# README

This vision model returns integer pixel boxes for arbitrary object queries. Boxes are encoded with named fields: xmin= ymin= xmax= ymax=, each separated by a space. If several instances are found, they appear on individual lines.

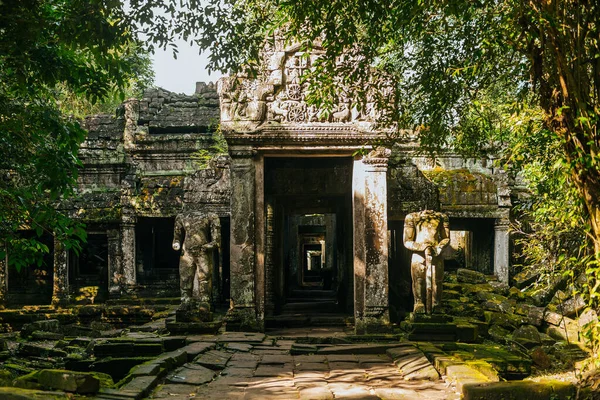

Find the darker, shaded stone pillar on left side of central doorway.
xmin=227 ymin=148 xmax=260 ymax=330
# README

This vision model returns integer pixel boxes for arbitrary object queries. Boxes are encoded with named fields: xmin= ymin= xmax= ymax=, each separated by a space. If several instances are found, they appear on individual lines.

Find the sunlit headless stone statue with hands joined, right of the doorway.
xmin=404 ymin=210 xmax=450 ymax=314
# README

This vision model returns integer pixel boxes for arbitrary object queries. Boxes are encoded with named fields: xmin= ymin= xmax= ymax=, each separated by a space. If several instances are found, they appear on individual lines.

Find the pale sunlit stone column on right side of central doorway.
xmin=357 ymin=149 xmax=389 ymax=331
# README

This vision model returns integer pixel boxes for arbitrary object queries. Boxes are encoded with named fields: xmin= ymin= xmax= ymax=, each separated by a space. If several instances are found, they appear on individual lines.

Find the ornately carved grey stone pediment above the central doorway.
xmin=218 ymin=38 xmax=391 ymax=128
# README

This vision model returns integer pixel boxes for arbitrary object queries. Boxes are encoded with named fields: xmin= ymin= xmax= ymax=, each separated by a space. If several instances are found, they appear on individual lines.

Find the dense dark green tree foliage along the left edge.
xmin=0 ymin=0 xmax=149 ymax=269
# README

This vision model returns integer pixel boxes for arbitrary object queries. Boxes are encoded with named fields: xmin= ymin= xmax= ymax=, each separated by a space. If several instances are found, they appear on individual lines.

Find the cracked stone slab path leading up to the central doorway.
xmin=149 ymin=333 xmax=460 ymax=400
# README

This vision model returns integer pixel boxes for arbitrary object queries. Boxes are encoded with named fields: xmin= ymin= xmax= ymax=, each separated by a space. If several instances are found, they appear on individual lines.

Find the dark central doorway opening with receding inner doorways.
xmin=265 ymin=157 xmax=354 ymax=324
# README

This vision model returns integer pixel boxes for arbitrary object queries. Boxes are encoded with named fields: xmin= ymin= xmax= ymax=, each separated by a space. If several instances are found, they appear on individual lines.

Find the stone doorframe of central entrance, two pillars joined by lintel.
xmin=227 ymin=141 xmax=390 ymax=333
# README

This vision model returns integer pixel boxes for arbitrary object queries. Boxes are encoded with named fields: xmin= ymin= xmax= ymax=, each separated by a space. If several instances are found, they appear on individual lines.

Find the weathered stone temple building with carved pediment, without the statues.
xmin=0 ymin=44 xmax=511 ymax=332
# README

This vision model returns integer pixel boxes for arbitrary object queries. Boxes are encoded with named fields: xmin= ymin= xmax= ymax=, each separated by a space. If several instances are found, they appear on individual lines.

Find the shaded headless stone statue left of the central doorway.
xmin=173 ymin=212 xmax=221 ymax=320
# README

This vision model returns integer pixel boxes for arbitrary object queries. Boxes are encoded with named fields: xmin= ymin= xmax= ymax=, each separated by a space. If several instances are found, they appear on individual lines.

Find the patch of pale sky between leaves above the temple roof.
xmin=152 ymin=40 xmax=222 ymax=94
